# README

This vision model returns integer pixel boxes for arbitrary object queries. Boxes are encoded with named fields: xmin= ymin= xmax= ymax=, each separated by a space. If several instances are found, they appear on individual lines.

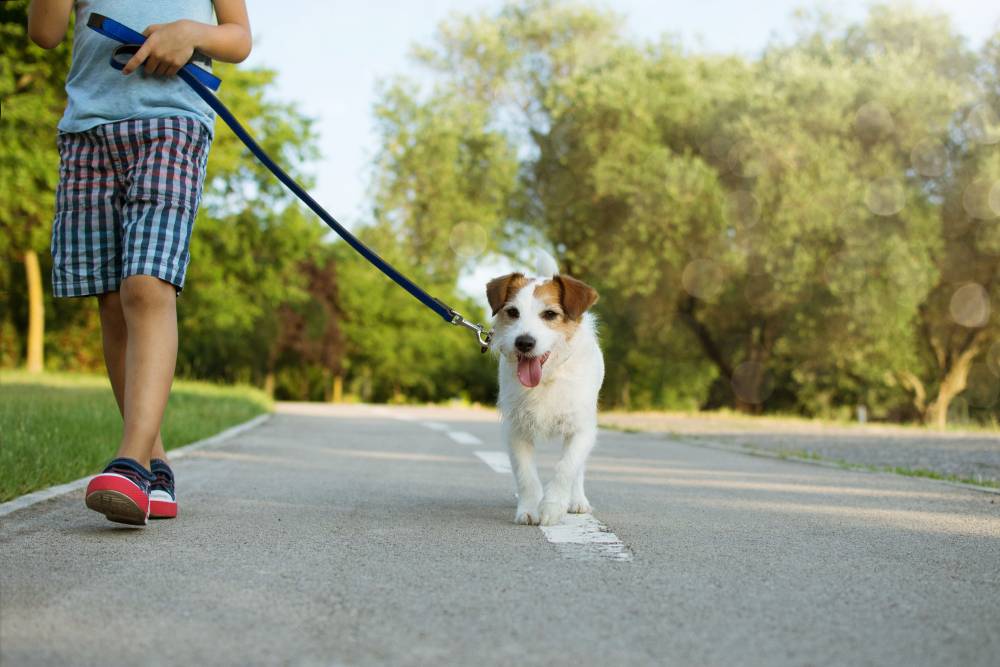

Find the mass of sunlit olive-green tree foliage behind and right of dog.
xmin=372 ymin=0 xmax=1000 ymax=420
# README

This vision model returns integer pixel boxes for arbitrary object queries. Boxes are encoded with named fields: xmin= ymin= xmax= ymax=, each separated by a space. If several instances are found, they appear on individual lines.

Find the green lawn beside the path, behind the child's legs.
xmin=0 ymin=370 xmax=271 ymax=502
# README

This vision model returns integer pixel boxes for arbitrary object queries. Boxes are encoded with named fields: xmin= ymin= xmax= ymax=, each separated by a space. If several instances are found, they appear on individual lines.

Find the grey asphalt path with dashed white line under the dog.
xmin=0 ymin=404 xmax=1000 ymax=667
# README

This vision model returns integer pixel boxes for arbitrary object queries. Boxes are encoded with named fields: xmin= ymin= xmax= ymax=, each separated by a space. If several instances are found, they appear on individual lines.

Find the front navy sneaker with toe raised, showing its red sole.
xmin=86 ymin=459 xmax=156 ymax=526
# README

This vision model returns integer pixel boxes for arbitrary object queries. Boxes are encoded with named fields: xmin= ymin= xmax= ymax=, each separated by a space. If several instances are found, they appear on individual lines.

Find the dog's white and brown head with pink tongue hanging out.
xmin=486 ymin=273 xmax=597 ymax=387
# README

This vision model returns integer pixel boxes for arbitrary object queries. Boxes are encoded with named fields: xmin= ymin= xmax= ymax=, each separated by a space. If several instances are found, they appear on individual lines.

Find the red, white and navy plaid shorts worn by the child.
xmin=52 ymin=116 xmax=212 ymax=297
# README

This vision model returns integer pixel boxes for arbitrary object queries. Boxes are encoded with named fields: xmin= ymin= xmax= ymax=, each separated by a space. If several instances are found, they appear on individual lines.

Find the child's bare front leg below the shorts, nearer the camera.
xmin=109 ymin=275 xmax=177 ymax=469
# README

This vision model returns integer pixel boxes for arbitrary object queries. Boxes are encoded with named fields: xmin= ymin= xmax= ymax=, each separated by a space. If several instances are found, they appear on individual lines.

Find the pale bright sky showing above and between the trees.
xmin=242 ymin=0 xmax=1000 ymax=296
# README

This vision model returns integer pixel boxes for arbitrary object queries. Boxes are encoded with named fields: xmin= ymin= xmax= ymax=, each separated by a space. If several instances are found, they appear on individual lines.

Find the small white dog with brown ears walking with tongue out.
xmin=486 ymin=255 xmax=604 ymax=526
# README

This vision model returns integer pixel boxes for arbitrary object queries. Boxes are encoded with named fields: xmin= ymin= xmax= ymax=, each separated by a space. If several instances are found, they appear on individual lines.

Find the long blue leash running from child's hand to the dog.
xmin=87 ymin=13 xmax=492 ymax=352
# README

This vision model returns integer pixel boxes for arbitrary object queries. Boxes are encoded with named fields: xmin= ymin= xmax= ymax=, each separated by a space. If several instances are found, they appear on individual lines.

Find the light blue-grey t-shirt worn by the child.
xmin=59 ymin=0 xmax=216 ymax=133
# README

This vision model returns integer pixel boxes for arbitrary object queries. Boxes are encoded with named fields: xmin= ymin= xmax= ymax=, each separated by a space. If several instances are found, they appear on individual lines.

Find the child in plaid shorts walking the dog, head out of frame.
xmin=28 ymin=0 xmax=251 ymax=525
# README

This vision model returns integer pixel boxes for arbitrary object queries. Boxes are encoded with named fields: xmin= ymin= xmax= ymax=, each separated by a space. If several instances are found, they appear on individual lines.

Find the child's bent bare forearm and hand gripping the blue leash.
xmin=122 ymin=0 xmax=253 ymax=75
